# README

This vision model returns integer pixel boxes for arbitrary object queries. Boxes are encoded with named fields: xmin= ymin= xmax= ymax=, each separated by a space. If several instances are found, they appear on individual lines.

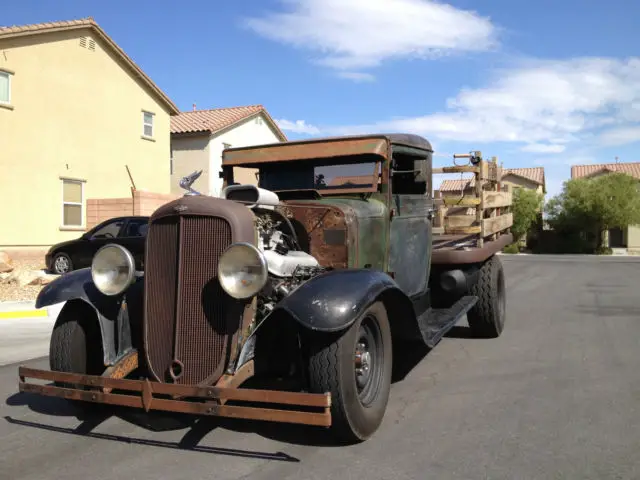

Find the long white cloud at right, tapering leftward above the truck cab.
xmin=308 ymin=58 xmax=640 ymax=153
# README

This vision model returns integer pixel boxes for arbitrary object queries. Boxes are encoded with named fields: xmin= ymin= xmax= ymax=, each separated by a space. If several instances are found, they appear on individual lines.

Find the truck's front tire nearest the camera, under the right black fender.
xmin=309 ymin=302 xmax=392 ymax=443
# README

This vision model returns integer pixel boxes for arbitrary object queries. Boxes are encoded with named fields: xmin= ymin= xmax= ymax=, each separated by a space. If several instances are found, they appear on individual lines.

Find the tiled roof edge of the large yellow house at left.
xmin=0 ymin=17 xmax=180 ymax=115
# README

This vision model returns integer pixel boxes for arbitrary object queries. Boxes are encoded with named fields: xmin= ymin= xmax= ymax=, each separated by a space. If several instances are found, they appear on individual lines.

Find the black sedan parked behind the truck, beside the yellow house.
xmin=45 ymin=216 xmax=149 ymax=275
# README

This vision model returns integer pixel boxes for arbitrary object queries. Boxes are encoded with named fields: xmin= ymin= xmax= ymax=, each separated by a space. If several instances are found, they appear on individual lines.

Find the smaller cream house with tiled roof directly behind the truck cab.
xmin=171 ymin=105 xmax=287 ymax=196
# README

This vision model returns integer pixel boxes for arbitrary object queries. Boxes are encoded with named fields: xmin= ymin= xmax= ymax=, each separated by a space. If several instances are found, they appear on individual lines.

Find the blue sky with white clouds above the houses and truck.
xmin=5 ymin=0 xmax=640 ymax=194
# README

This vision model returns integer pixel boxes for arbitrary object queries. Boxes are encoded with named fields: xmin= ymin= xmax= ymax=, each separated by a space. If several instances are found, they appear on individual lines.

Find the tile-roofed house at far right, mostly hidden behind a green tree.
xmin=571 ymin=162 xmax=640 ymax=254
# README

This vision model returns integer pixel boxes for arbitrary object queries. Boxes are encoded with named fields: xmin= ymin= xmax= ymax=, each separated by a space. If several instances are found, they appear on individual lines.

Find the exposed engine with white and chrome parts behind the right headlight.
xmin=254 ymin=208 xmax=325 ymax=318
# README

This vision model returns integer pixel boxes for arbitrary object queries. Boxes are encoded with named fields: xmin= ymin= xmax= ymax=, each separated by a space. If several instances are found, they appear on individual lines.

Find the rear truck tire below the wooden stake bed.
xmin=467 ymin=255 xmax=506 ymax=338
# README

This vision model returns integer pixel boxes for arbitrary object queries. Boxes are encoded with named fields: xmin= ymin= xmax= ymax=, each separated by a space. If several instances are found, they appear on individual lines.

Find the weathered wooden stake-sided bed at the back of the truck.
xmin=432 ymin=152 xmax=513 ymax=264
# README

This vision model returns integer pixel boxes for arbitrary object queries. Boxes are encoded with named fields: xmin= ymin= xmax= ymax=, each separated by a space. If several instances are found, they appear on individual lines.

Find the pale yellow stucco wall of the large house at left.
xmin=0 ymin=30 xmax=170 ymax=247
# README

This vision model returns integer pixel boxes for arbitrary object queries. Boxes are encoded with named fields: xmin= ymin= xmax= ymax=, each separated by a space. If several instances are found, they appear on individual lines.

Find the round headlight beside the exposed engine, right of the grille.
xmin=218 ymin=243 xmax=268 ymax=298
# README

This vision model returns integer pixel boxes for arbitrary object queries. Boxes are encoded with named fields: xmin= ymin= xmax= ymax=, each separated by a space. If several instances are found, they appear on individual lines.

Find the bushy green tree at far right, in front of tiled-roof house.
xmin=547 ymin=173 xmax=640 ymax=250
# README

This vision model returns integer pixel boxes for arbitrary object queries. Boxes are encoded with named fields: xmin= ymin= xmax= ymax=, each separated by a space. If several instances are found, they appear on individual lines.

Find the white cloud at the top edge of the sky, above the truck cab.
xmin=246 ymin=0 xmax=497 ymax=80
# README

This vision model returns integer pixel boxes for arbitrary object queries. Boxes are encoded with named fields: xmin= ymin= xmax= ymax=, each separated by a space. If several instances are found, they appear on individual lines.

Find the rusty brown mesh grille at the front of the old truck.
xmin=145 ymin=215 xmax=234 ymax=384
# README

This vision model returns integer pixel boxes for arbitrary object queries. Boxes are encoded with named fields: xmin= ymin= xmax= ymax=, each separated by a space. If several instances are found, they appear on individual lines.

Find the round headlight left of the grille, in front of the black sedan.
xmin=91 ymin=243 xmax=136 ymax=295
